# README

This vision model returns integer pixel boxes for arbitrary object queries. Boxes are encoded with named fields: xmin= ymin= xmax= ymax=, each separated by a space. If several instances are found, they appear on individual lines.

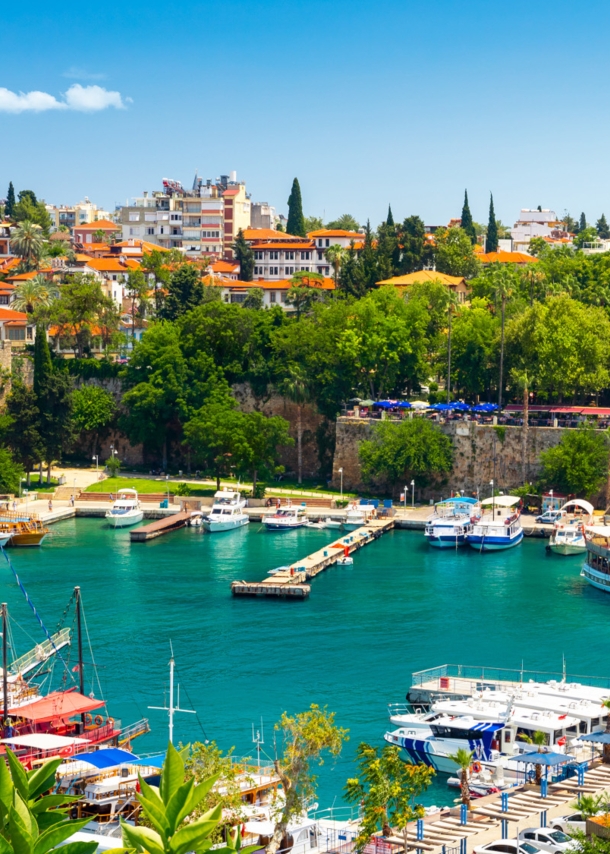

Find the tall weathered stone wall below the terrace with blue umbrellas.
xmin=333 ymin=417 xmax=605 ymax=506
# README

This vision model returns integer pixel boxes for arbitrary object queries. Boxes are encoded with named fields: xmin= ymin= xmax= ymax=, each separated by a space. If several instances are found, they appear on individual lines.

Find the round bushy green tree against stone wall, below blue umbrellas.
xmin=358 ymin=418 xmax=453 ymax=492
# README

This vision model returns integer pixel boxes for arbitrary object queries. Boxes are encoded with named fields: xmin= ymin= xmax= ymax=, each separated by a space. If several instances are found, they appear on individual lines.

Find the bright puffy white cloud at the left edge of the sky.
xmin=0 ymin=83 xmax=131 ymax=113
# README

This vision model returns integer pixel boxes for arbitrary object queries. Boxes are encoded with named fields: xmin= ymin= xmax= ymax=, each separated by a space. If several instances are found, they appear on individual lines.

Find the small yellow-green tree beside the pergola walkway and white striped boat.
xmin=345 ymin=743 xmax=435 ymax=852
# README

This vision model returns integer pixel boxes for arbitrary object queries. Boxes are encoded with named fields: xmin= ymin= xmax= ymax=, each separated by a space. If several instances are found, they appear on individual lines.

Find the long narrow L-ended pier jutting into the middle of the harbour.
xmin=231 ymin=519 xmax=394 ymax=599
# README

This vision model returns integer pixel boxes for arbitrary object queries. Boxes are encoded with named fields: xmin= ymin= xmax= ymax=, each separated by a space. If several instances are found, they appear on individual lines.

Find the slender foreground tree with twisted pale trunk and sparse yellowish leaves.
xmin=266 ymin=704 xmax=347 ymax=854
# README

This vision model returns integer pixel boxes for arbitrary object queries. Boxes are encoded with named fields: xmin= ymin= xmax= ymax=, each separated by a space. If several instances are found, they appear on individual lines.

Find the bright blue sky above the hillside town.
xmin=0 ymin=0 xmax=610 ymax=225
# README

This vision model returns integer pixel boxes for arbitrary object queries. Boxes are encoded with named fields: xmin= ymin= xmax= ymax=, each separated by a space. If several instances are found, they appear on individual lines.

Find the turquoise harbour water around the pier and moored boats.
xmin=2 ymin=519 xmax=610 ymax=806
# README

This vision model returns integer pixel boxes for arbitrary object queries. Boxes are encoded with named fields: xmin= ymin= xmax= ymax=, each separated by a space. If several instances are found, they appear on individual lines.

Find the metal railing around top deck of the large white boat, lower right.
xmin=411 ymin=664 xmax=610 ymax=691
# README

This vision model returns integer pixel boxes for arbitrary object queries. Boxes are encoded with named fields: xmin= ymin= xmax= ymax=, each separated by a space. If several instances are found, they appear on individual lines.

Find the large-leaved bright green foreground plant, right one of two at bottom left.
xmin=122 ymin=743 xmax=256 ymax=854
